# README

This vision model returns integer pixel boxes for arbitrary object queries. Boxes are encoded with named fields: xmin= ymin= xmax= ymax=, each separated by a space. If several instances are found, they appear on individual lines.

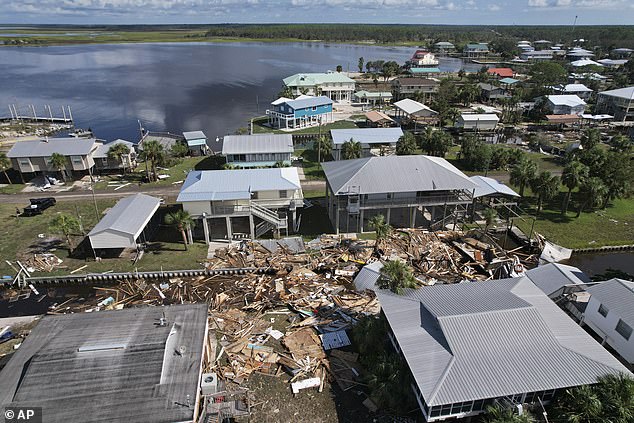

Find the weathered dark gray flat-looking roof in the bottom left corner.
xmin=0 ymin=304 xmax=207 ymax=423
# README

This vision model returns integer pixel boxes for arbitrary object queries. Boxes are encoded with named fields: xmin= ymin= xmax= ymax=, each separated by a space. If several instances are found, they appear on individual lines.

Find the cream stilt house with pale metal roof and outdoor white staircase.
xmin=176 ymin=167 xmax=304 ymax=243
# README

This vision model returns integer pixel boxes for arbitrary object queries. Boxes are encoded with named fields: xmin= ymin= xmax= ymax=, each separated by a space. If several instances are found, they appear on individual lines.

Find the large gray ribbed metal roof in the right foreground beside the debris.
xmin=376 ymin=278 xmax=629 ymax=405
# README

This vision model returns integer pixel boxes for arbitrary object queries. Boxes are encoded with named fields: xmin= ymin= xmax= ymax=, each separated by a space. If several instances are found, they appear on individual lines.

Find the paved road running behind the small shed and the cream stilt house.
xmin=0 ymin=181 xmax=326 ymax=204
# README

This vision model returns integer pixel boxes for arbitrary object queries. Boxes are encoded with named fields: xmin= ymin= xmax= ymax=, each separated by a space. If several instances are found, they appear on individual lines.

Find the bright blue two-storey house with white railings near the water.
xmin=266 ymin=95 xmax=334 ymax=129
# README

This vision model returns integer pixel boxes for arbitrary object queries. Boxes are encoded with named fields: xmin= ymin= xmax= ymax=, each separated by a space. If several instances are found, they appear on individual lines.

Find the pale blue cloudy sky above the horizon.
xmin=0 ymin=0 xmax=634 ymax=25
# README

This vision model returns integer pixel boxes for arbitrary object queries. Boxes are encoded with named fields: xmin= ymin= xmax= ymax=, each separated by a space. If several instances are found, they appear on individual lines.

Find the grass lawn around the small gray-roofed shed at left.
xmin=0 ymin=200 xmax=207 ymax=275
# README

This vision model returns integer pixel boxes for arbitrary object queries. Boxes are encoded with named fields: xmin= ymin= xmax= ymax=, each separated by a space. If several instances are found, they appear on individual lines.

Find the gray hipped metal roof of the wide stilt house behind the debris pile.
xmin=321 ymin=155 xmax=477 ymax=195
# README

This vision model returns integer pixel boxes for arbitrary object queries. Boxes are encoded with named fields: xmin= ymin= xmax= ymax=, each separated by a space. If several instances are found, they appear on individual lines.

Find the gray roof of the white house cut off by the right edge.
xmin=586 ymin=278 xmax=634 ymax=327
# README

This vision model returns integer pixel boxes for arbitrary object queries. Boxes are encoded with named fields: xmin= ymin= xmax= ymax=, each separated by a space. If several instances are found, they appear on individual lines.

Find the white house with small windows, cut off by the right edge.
xmin=581 ymin=279 xmax=634 ymax=364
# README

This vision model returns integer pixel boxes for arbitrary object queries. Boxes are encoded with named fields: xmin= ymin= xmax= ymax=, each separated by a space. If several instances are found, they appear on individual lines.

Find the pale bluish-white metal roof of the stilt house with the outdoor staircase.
xmin=176 ymin=167 xmax=301 ymax=203
